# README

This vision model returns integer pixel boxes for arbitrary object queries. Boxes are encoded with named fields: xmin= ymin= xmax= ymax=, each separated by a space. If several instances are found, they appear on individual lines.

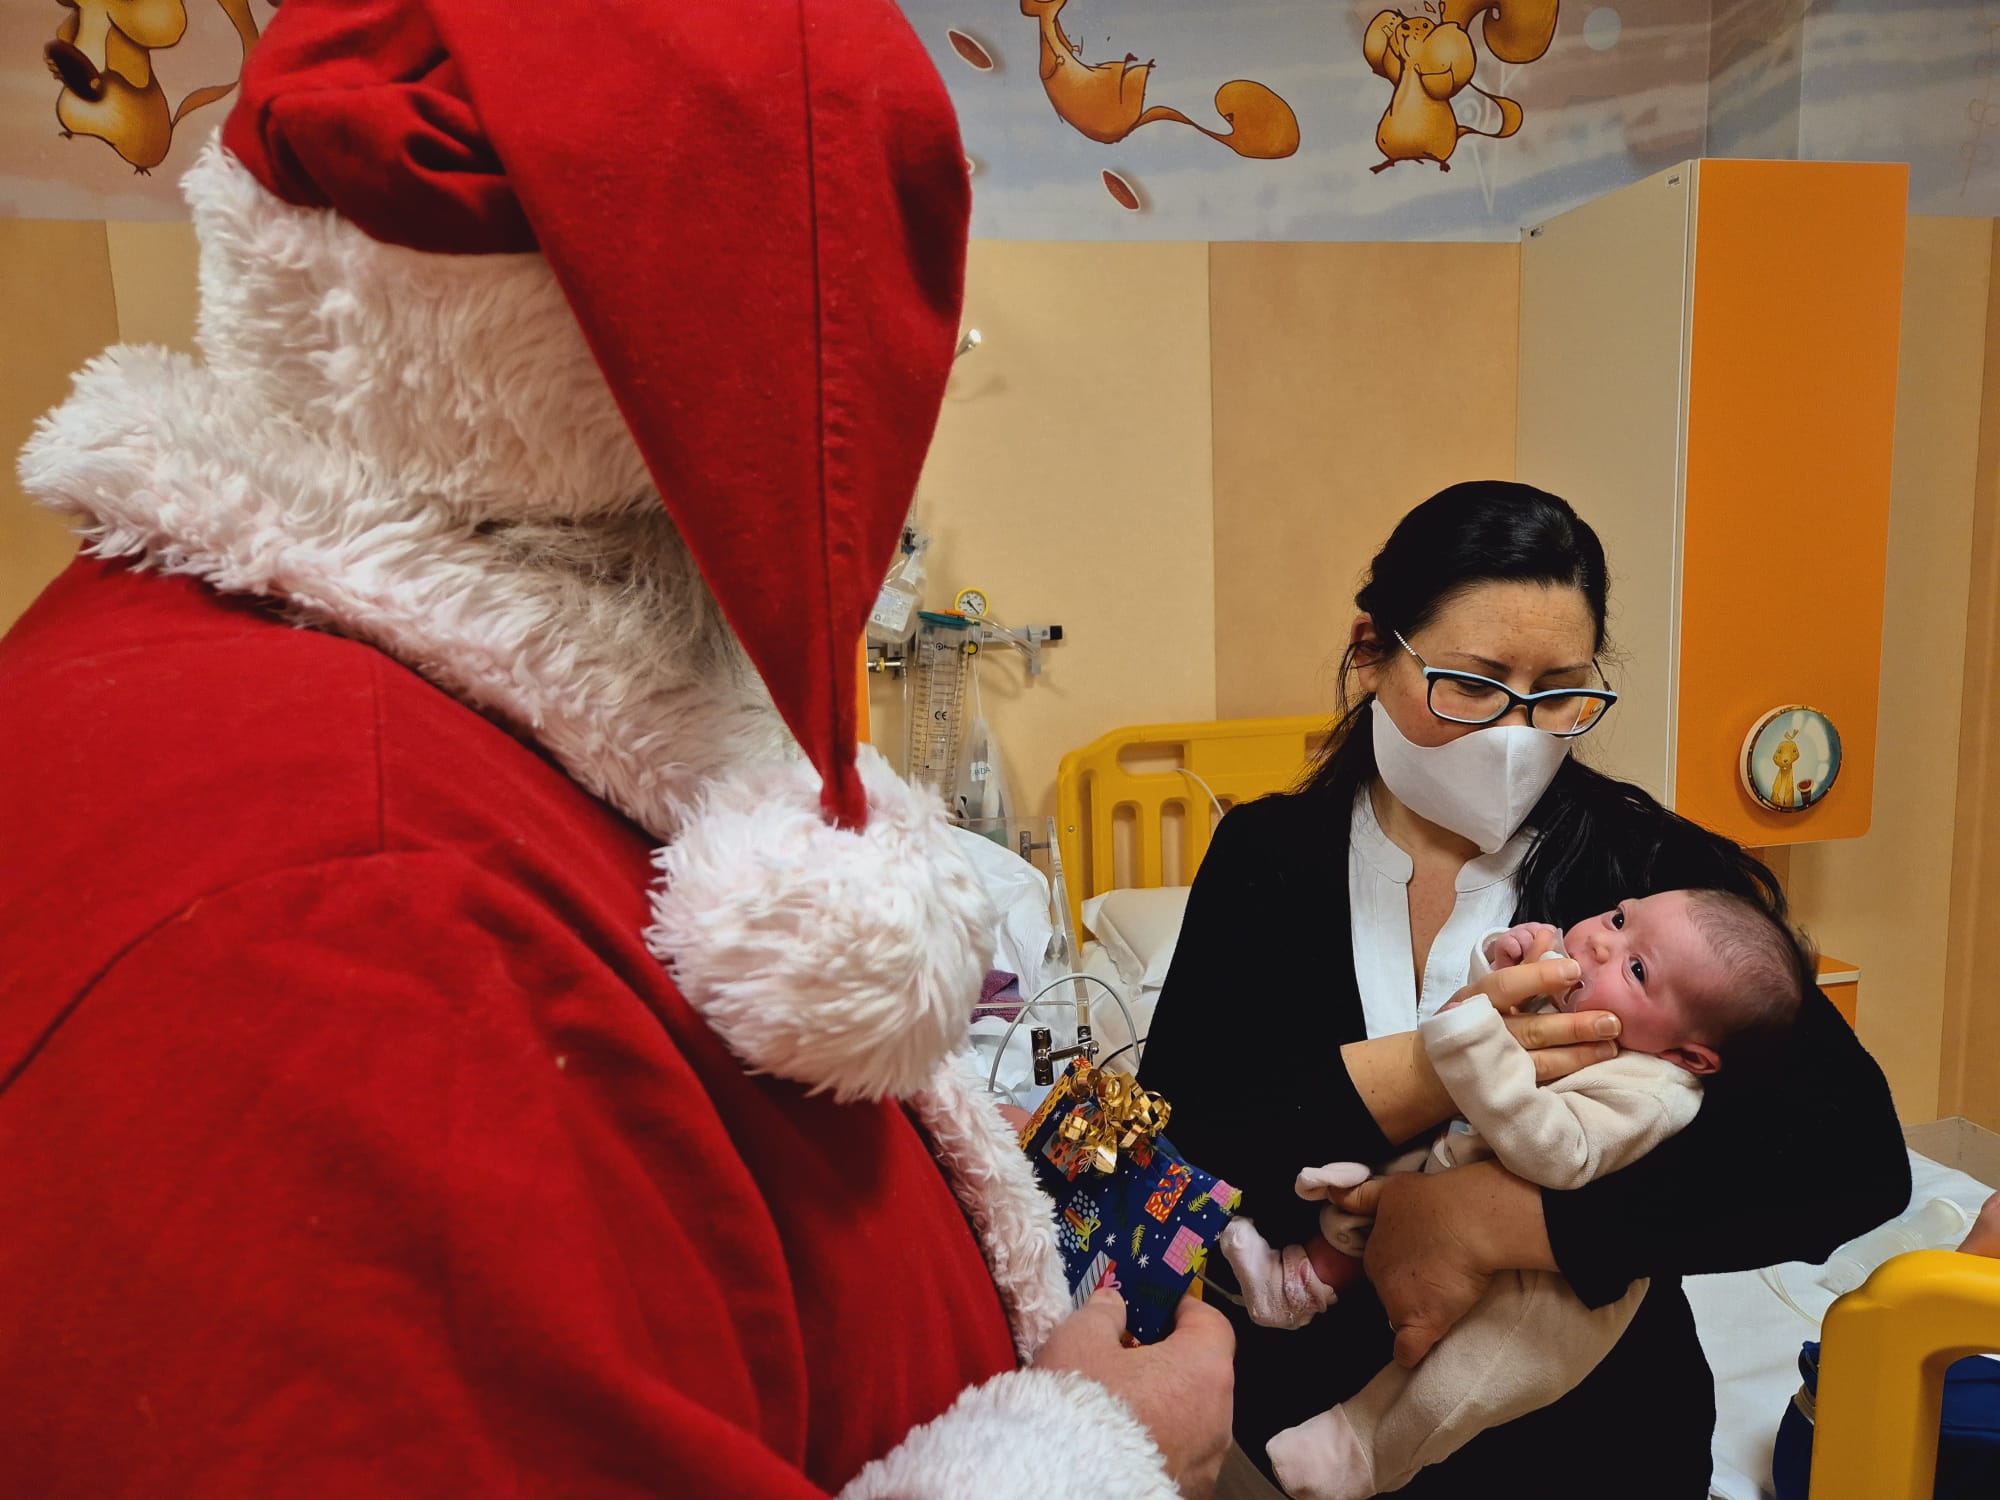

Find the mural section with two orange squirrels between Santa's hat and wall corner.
xmin=904 ymin=0 xmax=1710 ymax=240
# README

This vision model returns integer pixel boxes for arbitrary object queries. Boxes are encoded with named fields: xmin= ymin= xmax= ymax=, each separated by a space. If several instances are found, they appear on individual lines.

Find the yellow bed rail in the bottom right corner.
xmin=1812 ymin=1250 xmax=2000 ymax=1500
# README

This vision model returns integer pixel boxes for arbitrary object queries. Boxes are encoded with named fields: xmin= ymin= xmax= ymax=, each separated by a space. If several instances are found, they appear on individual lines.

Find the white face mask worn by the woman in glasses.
xmin=1374 ymin=698 xmax=1570 ymax=854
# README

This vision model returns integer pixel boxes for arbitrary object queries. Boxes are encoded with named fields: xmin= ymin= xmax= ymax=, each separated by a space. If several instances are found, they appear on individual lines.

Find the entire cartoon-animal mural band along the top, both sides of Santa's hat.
xmin=0 ymin=0 xmax=2000 ymax=240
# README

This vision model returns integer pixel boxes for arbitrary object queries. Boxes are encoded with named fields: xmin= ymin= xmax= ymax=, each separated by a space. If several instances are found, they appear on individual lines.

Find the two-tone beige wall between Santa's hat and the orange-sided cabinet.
xmin=870 ymin=242 xmax=1520 ymax=836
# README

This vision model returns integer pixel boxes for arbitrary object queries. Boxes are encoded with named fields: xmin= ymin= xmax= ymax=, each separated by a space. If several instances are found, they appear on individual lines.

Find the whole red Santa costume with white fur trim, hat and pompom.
xmin=0 ymin=0 xmax=1172 ymax=1500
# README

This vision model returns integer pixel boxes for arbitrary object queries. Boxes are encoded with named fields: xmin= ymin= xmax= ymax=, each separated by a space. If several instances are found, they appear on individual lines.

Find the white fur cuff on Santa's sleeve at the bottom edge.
xmin=840 ymin=1370 xmax=1178 ymax=1500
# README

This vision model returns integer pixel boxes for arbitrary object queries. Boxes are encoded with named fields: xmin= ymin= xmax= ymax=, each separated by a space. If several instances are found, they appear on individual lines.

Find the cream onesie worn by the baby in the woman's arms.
xmin=1268 ymin=988 xmax=1702 ymax=1500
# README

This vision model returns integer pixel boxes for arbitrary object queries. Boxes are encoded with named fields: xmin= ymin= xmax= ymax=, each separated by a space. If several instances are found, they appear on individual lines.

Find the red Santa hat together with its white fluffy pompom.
xmin=209 ymin=0 xmax=990 ymax=1098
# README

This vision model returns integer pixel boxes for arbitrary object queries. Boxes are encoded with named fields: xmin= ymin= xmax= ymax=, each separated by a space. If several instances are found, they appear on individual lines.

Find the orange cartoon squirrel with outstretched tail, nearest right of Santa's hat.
xmin=1020 ymin=0 xmax=1298 ymax=160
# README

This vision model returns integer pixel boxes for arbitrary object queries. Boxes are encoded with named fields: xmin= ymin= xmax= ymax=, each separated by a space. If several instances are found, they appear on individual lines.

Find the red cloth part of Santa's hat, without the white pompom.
xmin=222 ymin=0 xmax=970 ymax=828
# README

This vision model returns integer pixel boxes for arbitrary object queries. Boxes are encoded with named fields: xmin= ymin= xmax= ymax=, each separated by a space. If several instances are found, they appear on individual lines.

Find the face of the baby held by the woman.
xmin=1562 ymin=890 xmax=1728 ymax=1072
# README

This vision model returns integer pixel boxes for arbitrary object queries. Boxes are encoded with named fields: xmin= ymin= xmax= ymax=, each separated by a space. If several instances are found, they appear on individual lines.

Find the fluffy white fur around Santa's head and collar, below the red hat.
xmin=20 ymin=144 xmax=790 ymax=840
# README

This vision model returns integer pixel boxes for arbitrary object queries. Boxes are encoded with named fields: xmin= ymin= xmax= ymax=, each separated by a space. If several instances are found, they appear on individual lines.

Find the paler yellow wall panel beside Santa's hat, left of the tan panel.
xmin=888 ymin=242 xmax=1216 ymax=814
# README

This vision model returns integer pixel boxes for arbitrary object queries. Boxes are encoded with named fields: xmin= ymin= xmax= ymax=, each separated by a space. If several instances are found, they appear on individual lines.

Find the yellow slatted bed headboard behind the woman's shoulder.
xmin=1056 ymin=718 xmax=1328 ymax=932
